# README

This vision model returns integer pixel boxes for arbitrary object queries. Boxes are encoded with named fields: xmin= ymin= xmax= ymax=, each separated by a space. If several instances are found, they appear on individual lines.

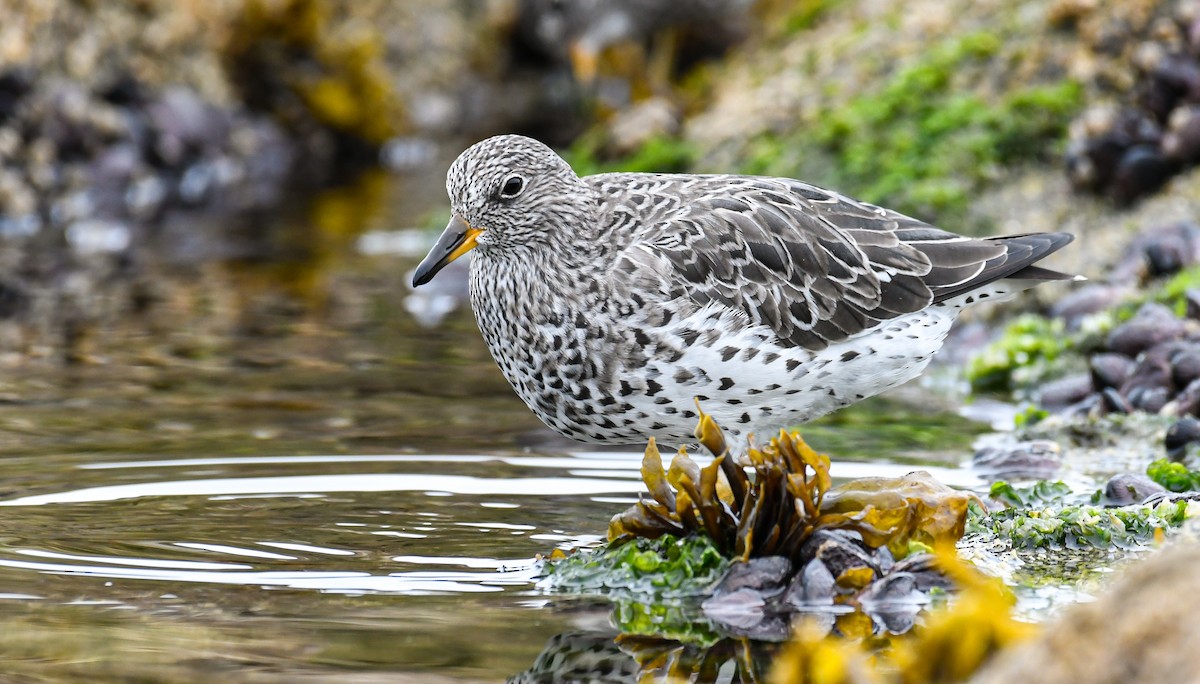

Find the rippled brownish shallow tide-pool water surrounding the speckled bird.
xmin=0 ymin=169 xmax=1099 ymax=682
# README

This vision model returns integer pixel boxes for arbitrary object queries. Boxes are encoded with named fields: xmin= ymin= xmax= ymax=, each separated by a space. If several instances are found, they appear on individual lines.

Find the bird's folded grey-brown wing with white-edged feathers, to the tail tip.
xmin=604 ymin=174 xmax=1070 ymax=349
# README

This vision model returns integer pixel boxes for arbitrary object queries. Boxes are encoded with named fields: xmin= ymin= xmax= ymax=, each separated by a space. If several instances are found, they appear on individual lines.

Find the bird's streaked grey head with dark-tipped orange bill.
xmin=413 ymin=136 xmax=594 ymax=287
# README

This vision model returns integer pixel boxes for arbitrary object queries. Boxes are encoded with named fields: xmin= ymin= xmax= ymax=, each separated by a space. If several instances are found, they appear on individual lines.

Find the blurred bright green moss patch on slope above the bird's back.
xmin=744 ymin=32 xmax=1082 ymax=220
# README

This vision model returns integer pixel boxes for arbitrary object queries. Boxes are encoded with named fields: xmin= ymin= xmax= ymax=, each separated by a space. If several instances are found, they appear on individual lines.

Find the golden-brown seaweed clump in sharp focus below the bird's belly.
xmin=608 ymin=410 xmax=972 ymax=560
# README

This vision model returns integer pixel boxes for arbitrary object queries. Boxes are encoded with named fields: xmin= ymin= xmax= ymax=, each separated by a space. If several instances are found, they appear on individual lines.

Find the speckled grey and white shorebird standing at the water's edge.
xmin=413 ymin=134 xmax=1081 ymax=445
